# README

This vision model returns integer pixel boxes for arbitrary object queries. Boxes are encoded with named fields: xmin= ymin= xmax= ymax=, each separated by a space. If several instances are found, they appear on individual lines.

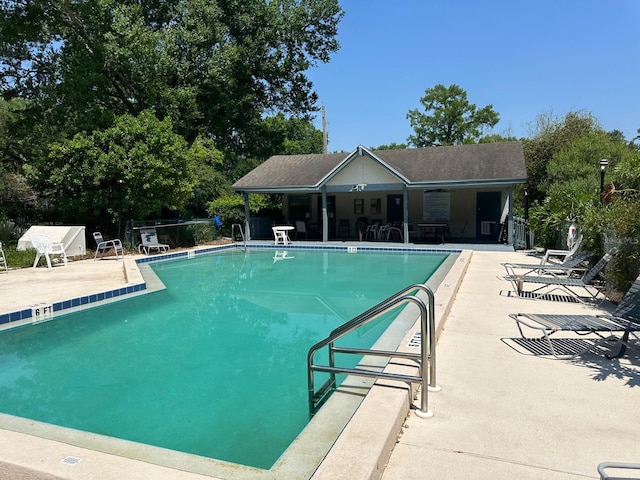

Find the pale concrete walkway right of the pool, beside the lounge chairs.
xmin=382 ymin=251 xmax=640 ymax=480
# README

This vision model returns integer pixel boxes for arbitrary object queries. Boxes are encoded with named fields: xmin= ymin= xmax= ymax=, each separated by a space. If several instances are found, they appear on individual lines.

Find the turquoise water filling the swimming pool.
xmin=0 ymin=250 xmax=446 ymax=468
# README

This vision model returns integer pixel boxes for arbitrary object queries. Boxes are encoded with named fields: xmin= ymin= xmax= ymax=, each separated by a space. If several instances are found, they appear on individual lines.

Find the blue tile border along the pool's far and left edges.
xmin=0 ymin=243 xmax=462 ymax=325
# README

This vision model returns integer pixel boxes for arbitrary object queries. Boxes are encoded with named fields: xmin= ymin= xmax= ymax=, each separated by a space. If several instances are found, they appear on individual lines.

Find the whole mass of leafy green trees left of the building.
xmin=0 ymin=0 xmax=343 ymax=232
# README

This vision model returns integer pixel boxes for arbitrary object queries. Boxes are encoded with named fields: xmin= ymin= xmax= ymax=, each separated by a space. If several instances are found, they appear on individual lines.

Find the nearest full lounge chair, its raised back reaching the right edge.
xmin=509 ymin=276 xmax=640 ymax=358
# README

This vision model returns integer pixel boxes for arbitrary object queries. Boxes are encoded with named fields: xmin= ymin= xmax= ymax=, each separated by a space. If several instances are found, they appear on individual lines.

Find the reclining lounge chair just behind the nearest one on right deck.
xmin=504 ymin=247 xmax=618 ymax=300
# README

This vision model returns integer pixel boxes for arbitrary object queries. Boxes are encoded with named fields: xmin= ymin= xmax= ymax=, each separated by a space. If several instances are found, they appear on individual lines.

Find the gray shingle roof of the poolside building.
xmin=233 ymin=142 xmax=527 ymax=191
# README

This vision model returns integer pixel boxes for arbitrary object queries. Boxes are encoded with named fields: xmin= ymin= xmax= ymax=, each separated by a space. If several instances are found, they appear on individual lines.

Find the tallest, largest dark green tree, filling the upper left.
xmin=0 ymin=0 xmax=343 ymax=156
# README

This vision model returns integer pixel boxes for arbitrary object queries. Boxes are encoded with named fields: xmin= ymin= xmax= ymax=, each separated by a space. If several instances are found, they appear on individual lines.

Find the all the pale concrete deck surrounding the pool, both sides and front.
xmin=0 ymin=245 xmax=640 ymax=480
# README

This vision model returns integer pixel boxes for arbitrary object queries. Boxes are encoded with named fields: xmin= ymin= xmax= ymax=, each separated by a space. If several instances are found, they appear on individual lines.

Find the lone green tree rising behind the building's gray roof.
xmin=407 ymin=84 xmax=500 ymax=147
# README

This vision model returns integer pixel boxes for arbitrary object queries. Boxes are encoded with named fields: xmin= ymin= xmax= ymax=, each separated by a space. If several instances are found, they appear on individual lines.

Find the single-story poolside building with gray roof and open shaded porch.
xmin=233 ymin=142 xmax=527 ymax=244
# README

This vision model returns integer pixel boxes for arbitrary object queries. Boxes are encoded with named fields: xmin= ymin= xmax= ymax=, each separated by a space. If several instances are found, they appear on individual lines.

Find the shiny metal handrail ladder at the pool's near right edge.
xmin=307 ymin=283 xmax=440 ymax=418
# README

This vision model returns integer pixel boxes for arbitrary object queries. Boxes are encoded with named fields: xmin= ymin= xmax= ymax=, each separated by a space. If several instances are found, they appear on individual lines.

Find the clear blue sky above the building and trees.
xmin=308 ymin=0 xmax=640 ymax=152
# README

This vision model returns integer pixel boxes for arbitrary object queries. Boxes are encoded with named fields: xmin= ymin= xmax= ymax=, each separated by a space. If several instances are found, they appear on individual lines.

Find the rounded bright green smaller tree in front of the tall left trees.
xmin=28 ymin=111 xmax=202 ymax=229
